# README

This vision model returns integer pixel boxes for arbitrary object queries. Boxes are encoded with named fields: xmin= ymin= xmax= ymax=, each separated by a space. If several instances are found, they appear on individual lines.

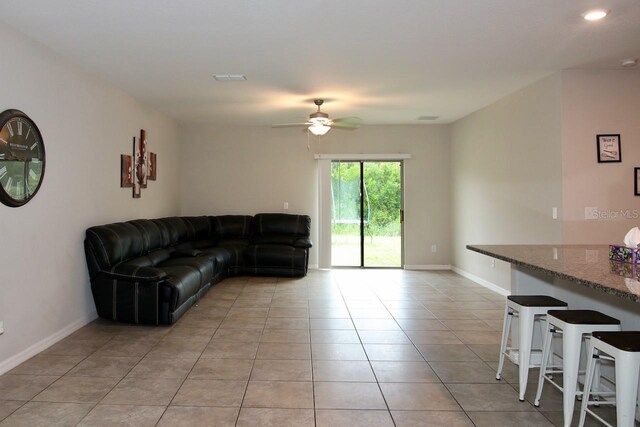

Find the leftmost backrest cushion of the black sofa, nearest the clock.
xmin=86 ymin=222 xmax=144 ymax=270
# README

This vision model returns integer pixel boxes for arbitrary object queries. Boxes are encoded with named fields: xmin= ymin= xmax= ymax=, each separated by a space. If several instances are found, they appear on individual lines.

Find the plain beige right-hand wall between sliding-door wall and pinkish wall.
xmin=450 ymin=74 xmax=562 ymax=290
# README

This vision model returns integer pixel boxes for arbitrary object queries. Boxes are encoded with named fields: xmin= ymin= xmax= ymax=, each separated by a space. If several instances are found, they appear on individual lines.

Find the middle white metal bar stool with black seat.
xmin=534 ymin=310 xmax=620 ymax=427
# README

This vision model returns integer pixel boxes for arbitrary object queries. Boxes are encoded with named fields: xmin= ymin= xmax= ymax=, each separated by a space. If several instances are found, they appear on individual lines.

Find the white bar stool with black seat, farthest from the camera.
xmin=496 ymin=295 xmax=567 ymax=401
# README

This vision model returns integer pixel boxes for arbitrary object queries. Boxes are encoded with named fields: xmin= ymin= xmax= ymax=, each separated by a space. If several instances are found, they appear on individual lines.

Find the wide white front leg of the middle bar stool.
xmin=562 ymin=328 xmax=582 ymax=427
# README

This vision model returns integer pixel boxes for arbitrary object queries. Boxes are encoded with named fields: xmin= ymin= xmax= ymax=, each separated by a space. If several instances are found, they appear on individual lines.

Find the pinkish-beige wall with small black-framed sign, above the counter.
xmin=562 ymin=70 xmax=640 ymax=244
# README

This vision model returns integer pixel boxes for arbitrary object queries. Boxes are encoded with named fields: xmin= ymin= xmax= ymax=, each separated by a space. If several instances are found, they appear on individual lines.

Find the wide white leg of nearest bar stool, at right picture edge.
xmin=615 ymin=352 xmax=640 ymax=427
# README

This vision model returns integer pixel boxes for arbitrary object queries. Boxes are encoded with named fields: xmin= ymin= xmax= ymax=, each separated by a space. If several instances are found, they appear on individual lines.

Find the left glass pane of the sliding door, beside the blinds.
xmin=331 ymin=161 xmax=361 ymax=267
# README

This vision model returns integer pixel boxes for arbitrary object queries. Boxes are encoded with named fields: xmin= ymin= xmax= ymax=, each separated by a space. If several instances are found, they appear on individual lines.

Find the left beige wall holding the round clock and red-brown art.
xmin=0 ymin=27 xmax=179 ymax=373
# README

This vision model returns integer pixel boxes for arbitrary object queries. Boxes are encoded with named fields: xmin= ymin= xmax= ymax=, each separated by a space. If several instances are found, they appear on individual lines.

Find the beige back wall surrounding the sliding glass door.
xmin=181 ymin=125 xmax=450 ymax=266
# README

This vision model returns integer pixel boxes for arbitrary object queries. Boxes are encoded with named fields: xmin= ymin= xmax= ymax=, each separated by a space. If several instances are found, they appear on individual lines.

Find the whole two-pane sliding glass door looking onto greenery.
xmin=331 ymin=161 xmax=403 ymax=268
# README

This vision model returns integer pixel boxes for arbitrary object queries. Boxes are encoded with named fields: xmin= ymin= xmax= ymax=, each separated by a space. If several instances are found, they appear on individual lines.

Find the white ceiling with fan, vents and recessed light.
xmin=0 ymin=0 xmax=640 ymax=125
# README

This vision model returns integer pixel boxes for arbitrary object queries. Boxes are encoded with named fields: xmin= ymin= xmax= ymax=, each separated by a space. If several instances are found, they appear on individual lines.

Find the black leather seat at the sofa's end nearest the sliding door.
xmin=245 ymin=244 xmax=307 ymax=274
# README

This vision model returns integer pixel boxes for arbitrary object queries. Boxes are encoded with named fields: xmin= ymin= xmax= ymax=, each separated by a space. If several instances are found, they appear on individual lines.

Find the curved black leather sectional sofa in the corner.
xmin=84 ymin=213 xmax=311 ymax=324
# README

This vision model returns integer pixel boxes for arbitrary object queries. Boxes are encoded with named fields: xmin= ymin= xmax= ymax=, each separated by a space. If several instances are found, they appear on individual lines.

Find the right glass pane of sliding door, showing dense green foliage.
xmin=363 ymin=162 xmax=402 ymax=267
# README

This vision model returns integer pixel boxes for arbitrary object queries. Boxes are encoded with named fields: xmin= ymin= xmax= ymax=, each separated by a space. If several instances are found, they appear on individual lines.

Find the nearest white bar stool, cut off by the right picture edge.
xmin=578 ymin=331 xmax=640 ymax=427
